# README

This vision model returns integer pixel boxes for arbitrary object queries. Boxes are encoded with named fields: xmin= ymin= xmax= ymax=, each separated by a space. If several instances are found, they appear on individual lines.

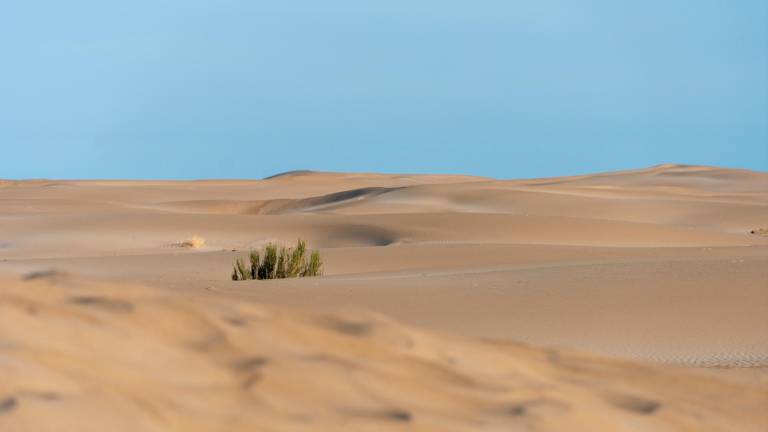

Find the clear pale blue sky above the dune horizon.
xmin=0 ymin=0 xmax=768 ymax=179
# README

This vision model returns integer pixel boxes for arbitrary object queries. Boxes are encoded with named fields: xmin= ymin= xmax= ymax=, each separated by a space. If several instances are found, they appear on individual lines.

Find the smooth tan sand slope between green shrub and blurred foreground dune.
xmin=215 ymin=250 xmax=768 ymax=367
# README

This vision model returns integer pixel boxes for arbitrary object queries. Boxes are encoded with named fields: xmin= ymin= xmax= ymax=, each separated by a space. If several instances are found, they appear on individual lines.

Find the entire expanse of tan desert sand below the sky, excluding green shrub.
xmin=0 ymin=165 xmax=768 ymax=431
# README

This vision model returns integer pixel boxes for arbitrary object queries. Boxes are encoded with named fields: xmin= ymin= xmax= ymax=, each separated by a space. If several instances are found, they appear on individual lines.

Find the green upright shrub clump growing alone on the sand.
xmin=232 ymin=239 xmax=323 ymax=280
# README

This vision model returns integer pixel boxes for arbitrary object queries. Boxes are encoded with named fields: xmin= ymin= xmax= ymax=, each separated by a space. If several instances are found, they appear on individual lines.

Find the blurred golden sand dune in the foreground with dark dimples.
xmin=0 ymin=273 xmax=768 ymax=432
